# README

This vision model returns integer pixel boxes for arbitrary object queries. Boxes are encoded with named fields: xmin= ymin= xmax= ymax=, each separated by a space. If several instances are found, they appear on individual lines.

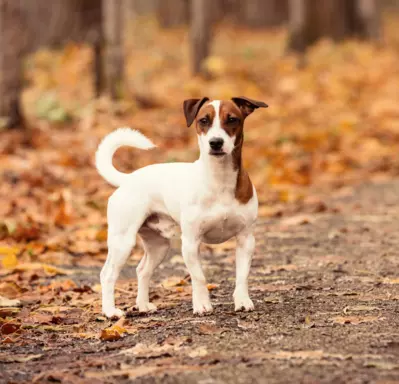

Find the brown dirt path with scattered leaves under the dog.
xmin=0 ymin=182 xmax=399 ymax=384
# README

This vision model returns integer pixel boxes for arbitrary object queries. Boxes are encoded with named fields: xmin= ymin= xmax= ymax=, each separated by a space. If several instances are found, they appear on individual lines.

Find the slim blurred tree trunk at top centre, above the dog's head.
xmin=190 ymin=0 xmax=212 ymax=74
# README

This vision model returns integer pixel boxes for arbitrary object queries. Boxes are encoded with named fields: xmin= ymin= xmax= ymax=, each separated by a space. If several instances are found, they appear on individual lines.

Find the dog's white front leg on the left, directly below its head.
xmin=182 ymin=233 xmax=212 ymax=314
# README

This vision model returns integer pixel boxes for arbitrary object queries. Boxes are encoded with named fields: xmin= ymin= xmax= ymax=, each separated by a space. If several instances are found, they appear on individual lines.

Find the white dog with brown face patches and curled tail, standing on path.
xmin=96 ymin=97 xmax=267 ymax=318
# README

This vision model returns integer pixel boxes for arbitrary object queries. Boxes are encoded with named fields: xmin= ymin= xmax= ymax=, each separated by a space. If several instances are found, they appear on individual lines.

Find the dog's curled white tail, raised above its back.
xmin=96 ymin=128 xmax=156 ymax=187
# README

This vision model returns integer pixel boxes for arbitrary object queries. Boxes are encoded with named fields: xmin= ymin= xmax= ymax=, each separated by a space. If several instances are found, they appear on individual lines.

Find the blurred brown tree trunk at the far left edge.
xmin=0 ymin=0 xmax=25 ymax=128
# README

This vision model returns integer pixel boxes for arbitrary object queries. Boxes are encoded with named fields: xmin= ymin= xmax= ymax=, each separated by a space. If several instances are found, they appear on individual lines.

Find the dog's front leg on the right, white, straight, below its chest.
xmin=233 ymin=231 xmax=255 ymax=311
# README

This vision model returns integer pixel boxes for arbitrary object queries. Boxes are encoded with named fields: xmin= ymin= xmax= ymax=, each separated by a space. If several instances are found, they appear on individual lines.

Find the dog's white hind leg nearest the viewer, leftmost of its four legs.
xmin=100 ymin=190 xmax=147 ymax=317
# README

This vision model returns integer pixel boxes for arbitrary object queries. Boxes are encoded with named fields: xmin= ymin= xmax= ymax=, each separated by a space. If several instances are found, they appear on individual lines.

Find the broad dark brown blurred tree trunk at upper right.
xmin=289 ymin=0 xmax=380 ymax=51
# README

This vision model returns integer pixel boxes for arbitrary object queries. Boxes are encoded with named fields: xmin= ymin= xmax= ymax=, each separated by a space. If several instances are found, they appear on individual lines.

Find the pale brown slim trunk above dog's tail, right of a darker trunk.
xmin=103 ymin=0 xmax=124 ymax=100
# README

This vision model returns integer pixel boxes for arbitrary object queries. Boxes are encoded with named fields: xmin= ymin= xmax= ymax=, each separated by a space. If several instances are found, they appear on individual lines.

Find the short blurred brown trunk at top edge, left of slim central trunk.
xmin=158 ymin=0 xmax=190 ymax=28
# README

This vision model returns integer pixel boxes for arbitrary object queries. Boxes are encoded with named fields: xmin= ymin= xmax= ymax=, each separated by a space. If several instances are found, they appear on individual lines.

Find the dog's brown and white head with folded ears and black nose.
xmin=183 ymin=97 xmax=267 ymax=157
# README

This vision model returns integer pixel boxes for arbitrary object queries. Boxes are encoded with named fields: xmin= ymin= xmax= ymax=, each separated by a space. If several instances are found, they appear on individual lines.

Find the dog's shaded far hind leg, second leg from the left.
xmin=136 ymin=227 xmax=170 ymax=312
